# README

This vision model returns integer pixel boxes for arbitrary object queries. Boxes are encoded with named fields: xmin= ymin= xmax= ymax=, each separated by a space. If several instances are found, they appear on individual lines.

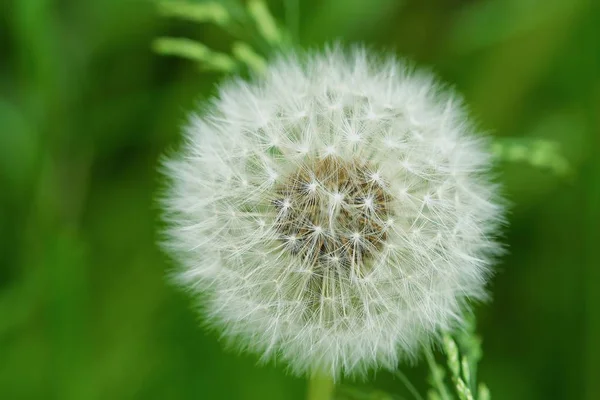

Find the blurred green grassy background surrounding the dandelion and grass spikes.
xmin=0 ymin=0 xmax=600 ymax=400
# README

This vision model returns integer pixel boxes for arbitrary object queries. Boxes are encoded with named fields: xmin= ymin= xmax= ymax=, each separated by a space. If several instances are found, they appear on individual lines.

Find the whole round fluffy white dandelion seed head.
xmin=163 ymin=49 xmax=503 ymax=378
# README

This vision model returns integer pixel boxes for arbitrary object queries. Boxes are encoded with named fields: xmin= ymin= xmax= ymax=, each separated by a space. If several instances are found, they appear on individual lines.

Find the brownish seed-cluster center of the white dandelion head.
xmin=273 ymin=156 xmax=391 ymax=274
